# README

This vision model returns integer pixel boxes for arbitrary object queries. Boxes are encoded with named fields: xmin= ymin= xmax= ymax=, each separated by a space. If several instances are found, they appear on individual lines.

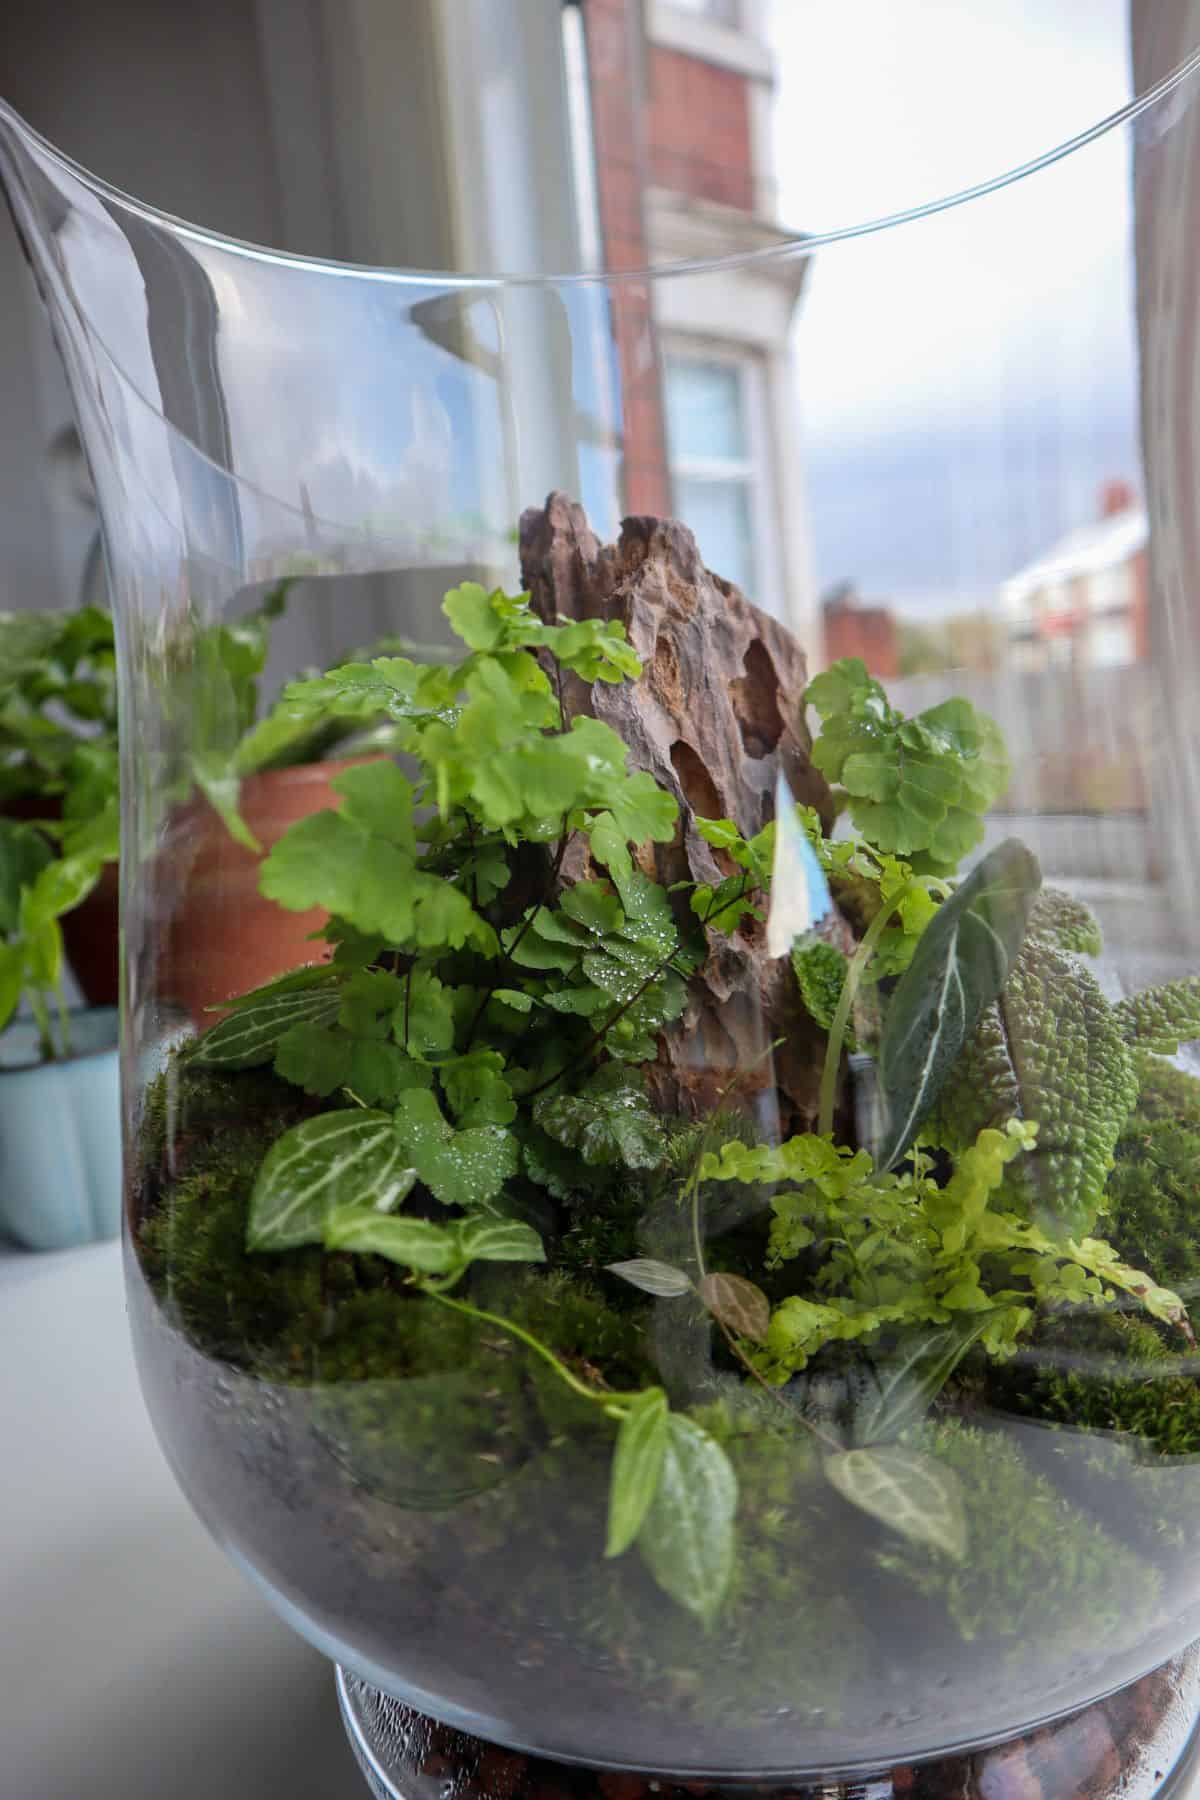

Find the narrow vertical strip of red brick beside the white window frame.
xmin=583 ymin=0 xmax=671 ymax=517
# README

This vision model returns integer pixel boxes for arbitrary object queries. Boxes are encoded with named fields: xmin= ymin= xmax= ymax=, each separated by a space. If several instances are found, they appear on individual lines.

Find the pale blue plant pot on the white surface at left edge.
xmin=0 ymin=1006 xmax=121 ymax=1249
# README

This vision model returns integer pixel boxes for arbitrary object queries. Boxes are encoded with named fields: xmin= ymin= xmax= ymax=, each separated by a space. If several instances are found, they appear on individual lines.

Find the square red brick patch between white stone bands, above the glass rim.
xmin=649 ymin=47 xmax=754 ymax=212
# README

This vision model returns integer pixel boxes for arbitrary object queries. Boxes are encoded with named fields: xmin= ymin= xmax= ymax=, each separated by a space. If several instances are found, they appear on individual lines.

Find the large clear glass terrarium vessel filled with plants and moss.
xmin=0 ymin=10 xmax=1200 ymax=1795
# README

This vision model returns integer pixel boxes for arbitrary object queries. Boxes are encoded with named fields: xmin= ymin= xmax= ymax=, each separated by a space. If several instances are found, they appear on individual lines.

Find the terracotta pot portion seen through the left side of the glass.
xmin=153 ymin=756 xmax=371 ymax=1030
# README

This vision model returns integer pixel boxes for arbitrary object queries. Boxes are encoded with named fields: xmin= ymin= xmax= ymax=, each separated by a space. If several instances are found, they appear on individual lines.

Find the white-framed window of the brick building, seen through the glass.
xmin=666 ymin=353 xmax=761 ymax=596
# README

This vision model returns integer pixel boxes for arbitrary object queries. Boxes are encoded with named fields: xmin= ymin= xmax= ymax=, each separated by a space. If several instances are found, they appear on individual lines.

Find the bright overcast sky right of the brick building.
xmin=774 ymin=0 xmax=1139 ymax=617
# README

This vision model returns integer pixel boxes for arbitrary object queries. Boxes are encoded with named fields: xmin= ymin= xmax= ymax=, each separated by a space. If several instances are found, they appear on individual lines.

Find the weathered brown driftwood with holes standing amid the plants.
xmin=520 ymin=493 xmax=845 ymax=1132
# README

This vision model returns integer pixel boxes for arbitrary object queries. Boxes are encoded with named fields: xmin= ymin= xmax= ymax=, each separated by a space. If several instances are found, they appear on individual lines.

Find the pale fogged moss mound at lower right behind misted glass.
xmin=876 ymin=1422 xmax=1162 ymax=1656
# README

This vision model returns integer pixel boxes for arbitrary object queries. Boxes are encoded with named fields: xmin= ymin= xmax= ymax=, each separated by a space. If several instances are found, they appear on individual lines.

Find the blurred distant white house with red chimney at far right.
xmin=1000 ymin=481 xmax=1150 ymax=673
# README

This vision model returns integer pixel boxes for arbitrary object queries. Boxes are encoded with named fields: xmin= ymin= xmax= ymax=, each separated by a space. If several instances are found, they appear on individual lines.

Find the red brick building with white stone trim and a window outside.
xmin=581 ymin=0 xmax=817 ymax=650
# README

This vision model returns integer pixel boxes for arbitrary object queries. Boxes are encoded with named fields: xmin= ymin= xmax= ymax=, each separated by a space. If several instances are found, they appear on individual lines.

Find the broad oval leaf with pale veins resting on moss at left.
xmin=246 ymin=1107 xmax=416 ymax=1251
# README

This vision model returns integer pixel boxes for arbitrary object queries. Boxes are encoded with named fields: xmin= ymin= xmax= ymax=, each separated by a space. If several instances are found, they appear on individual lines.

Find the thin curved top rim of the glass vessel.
xmin=0 ymin=35 xmax=1200 ymax=292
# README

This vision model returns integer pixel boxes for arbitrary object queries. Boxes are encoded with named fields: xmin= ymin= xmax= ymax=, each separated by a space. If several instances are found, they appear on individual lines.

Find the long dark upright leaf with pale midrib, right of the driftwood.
xmin=874 ymin=839 xmax=1042 ymax=1168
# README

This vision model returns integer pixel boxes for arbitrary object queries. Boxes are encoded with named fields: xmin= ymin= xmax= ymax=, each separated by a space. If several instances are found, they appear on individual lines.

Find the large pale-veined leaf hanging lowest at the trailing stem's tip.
xmin=637 ymin=1413 xmax=738 ymax=1625
